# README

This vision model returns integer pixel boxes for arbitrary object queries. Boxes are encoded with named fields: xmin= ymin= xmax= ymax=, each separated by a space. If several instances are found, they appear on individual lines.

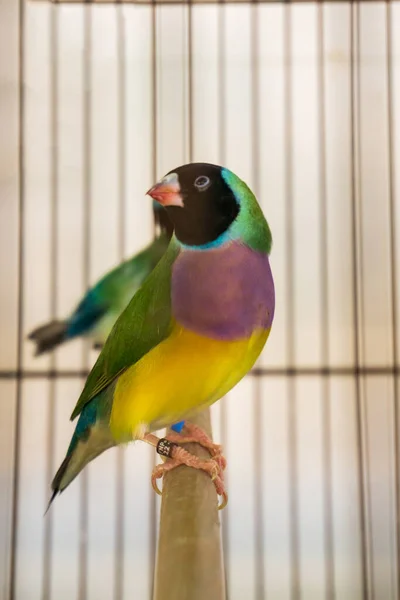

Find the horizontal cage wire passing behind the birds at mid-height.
xmin=0 ymin=365 xmax=400 ymax=379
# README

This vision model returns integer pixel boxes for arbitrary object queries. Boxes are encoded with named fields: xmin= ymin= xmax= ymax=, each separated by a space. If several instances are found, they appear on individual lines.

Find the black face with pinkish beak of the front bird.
xmin=147 ymin=163 xmax=239 ymax=246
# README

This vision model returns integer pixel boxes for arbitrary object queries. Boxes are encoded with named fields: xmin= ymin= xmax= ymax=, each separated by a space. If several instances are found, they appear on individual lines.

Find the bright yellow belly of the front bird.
xmin=110 ymin=324 xmax=269 ymax=441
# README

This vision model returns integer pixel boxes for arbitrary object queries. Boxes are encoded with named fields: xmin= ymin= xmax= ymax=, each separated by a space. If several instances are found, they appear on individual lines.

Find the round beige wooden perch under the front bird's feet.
xmin=154 ymin=409 xmax=225 ymax=600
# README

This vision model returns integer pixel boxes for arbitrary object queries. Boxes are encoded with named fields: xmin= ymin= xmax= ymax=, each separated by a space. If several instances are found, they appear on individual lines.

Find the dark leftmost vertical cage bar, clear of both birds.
xmin=10 ymin=0 xmax=25 ymax=600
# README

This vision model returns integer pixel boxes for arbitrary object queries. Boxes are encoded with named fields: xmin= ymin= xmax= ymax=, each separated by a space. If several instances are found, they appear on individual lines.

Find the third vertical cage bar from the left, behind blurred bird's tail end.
xmin=78 ymin=3 xmax=92 ymax=600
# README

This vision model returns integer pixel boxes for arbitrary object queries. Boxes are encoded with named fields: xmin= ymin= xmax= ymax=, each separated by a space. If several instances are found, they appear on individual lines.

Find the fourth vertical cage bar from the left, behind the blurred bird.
xmin=114 ymin=2 xmax=126 ymax=600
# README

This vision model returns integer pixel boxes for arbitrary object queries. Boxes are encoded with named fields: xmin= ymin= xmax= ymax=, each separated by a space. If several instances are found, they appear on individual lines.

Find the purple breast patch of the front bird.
xmin=172 ymin=242 xmax=275 ymax=340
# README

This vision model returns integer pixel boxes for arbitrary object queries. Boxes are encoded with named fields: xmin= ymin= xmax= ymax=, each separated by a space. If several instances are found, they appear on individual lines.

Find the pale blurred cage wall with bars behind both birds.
xmin=0 ymin=0 xmax=400 ymax=600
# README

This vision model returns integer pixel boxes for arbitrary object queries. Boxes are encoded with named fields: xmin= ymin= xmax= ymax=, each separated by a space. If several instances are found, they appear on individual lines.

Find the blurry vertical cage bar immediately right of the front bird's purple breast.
xmin=283 ymin=2 xmax=300 ymax=600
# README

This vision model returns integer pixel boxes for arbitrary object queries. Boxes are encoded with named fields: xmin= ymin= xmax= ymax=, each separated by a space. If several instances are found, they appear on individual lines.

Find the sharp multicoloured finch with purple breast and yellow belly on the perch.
xmin=49 ymin=163 xmax=275 ymax=507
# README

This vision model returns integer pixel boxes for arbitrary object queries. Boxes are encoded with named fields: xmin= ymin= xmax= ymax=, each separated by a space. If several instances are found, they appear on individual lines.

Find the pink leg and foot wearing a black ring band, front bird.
xmin=141 ymin=433 xmax=228 ymax=509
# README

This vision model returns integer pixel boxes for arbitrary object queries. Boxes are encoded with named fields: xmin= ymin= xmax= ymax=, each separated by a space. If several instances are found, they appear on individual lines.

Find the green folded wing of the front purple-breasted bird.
xmin=71 ymin=237 xmax=179 ymax=420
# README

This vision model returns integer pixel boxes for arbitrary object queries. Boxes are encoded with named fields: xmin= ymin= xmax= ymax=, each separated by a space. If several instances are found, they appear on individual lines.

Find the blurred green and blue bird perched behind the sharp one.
xmin=28 ymin=202 xmax=172 ymax=356
